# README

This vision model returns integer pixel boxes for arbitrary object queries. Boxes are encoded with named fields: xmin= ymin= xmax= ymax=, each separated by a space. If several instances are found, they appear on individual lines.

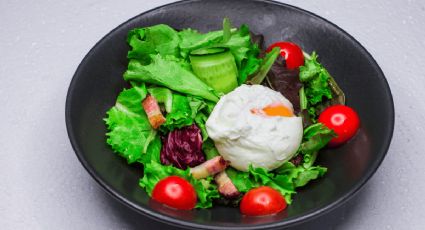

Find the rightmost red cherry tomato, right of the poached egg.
xmin=319 ymin=105 xmax=360 ymax=146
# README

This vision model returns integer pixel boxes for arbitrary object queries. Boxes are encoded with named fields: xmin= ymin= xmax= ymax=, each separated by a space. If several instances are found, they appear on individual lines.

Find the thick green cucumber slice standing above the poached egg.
xmin=190 ymin=47 xmax=238 ymax=93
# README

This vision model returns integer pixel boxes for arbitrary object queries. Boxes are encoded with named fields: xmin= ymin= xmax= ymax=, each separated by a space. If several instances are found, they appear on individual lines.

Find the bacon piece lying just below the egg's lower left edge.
xmin=190 ymin=156 xmax=229 ymax=179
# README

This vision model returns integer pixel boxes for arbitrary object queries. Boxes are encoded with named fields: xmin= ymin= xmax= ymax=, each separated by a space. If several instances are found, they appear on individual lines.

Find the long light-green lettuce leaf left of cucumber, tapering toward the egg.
xmin=124 ymin=55 xmax=218 ymax=102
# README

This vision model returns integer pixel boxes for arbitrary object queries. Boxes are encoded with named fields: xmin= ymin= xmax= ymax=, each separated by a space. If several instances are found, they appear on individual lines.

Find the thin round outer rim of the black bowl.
xmin=65 ymin=0 xmax=395 ymax=230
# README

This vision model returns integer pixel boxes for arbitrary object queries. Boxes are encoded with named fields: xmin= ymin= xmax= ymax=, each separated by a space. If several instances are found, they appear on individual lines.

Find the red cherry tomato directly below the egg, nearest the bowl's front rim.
xmin=240 ymin=186 xmax=286 ymax=216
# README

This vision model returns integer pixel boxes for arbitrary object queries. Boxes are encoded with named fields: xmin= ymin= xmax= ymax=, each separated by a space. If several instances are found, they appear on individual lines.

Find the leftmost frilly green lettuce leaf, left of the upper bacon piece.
xmin=104 ymin=85 xmax=161 ymax=163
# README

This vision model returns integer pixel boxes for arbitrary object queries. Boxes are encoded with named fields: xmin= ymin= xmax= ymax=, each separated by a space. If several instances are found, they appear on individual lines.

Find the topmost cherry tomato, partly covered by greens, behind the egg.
xmin=266 ymin=42 xmax=304 ymax=69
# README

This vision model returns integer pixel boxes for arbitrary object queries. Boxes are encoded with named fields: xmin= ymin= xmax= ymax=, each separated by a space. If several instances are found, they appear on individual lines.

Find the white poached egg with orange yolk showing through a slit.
xmin=206 ymin=85 xmax=303 ymax=171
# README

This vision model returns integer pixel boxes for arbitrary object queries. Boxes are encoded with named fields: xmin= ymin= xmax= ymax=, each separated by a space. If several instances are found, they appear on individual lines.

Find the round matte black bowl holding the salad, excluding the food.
xmin=66 ymin=0 xmax=394 ymax=229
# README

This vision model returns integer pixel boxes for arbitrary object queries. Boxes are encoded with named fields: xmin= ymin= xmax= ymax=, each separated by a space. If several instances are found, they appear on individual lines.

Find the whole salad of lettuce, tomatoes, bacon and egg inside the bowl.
xmin=104 ymin=18 xmax=360 ymax=216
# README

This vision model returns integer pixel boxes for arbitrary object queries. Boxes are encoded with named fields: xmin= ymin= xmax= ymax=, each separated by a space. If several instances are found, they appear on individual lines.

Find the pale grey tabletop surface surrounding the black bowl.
xmin=0 ymin=0 xmax=425 ymax=229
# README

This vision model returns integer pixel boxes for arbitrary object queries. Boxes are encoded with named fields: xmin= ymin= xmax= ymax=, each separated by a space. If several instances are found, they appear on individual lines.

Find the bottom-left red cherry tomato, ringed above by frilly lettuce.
xmin=152 ymin=176 xmax=197 ymax=210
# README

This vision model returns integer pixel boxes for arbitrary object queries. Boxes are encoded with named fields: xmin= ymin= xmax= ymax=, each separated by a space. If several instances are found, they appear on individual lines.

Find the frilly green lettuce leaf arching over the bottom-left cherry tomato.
xmin=139 ymin=161 xmax=220 ymax=208
